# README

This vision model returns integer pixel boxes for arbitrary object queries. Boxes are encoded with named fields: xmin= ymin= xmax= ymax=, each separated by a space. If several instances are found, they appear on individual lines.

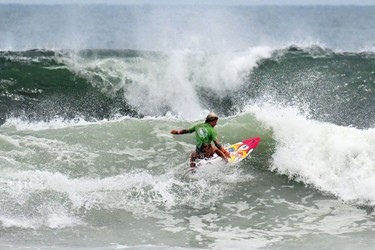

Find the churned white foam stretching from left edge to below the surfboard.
xmin=0 ymin=157 xmax=254 ymax=231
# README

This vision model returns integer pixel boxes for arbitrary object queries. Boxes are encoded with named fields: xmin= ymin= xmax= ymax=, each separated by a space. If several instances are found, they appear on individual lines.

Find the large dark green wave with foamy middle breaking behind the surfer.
xmin=0 ymin=47 xmax=375 ymax=128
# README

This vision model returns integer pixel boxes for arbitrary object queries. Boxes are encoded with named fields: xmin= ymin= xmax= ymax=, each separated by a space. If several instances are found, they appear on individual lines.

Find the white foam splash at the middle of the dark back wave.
xmin=61 ymin=47 xmax=273 ymax=119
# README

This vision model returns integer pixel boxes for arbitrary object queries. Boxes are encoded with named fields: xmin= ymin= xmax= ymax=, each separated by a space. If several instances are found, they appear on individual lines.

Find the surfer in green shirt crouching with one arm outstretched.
xmin=171 ymin=112 xmax=230 ymax=168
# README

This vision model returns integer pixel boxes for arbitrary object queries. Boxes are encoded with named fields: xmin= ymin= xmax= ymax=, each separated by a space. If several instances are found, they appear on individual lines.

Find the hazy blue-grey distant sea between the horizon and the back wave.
xmin=0 ymin=5 xmax=375 ymax=52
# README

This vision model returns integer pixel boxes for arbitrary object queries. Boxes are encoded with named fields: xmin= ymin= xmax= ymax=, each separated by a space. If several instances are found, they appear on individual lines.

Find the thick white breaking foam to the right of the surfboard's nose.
xmin=249 ymin=104 xmax=375 ymax=204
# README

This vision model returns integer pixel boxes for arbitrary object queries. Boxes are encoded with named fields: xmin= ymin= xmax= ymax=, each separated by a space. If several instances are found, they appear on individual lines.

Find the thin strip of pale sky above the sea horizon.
xmin=0 ymin=0 xmax=375 ymax=5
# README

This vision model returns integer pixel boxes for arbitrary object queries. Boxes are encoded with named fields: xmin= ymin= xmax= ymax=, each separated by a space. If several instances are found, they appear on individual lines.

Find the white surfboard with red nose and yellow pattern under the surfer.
xmin=185 ymin=137 xmax=260 ymax=175
